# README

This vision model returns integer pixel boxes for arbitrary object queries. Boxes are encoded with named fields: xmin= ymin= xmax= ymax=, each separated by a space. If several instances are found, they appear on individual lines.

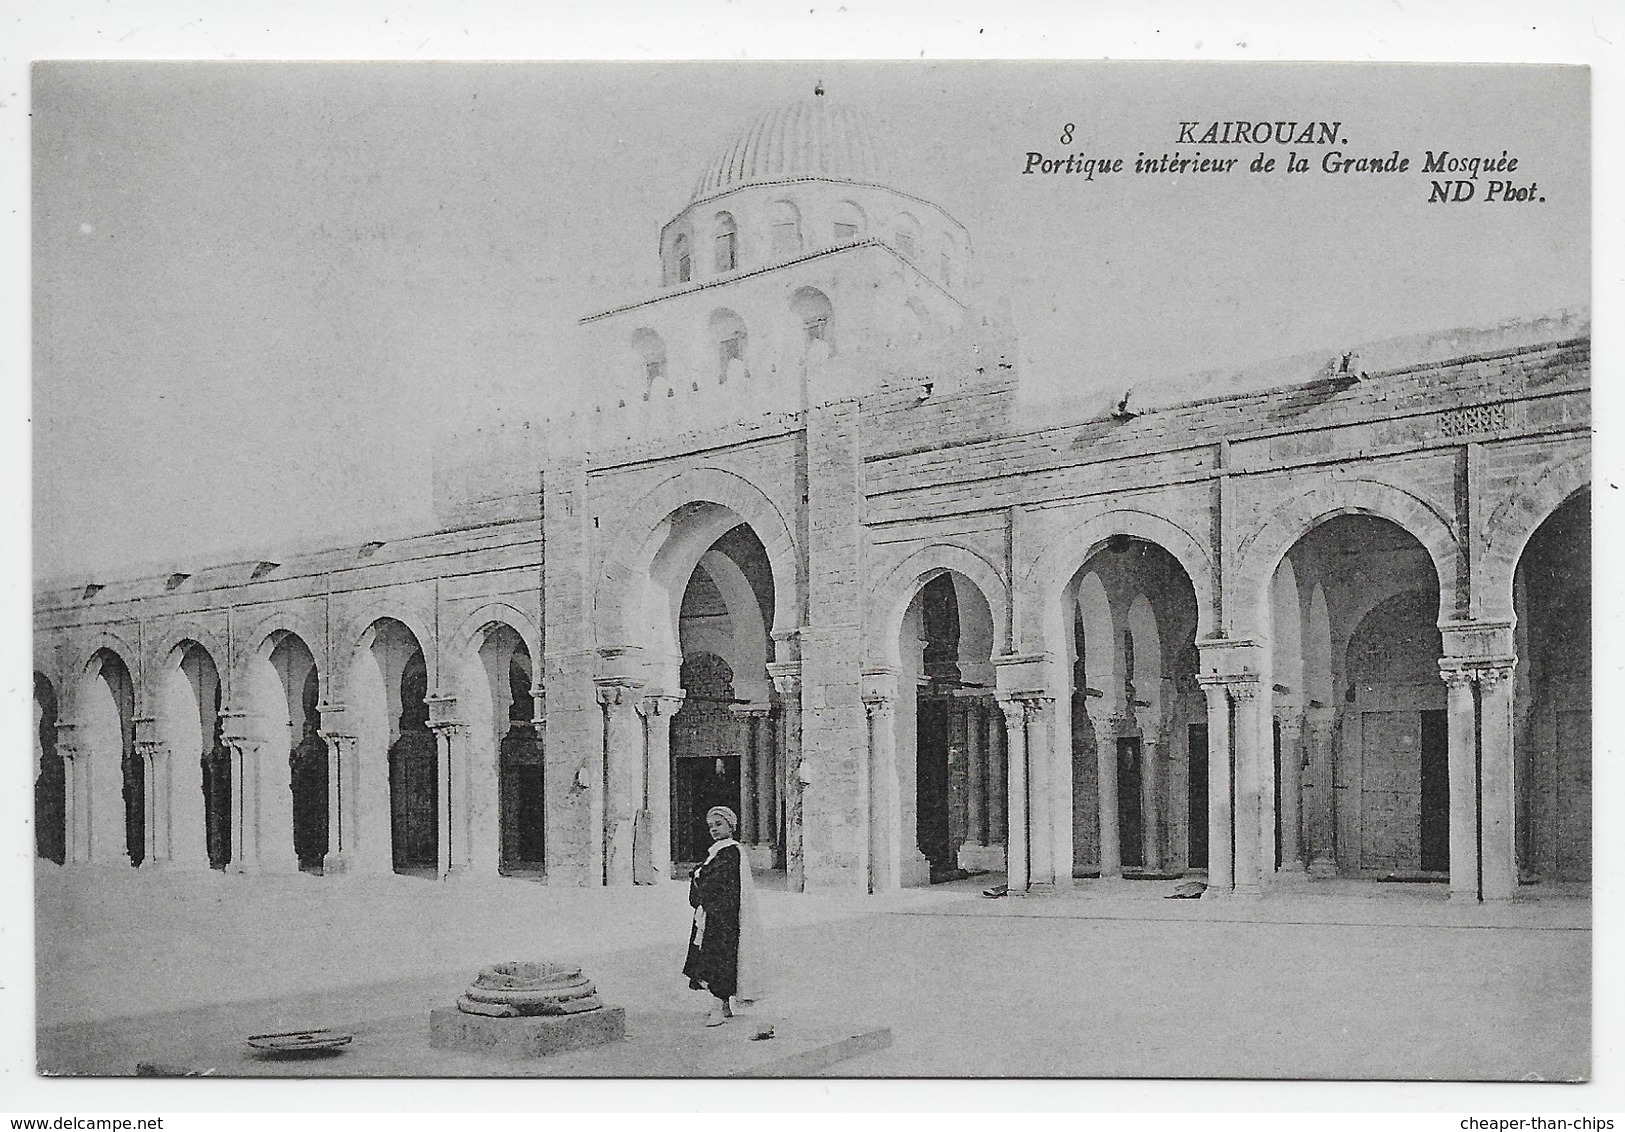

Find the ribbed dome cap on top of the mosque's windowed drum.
xmin=692 ymin=94 xmax=889 ymax=200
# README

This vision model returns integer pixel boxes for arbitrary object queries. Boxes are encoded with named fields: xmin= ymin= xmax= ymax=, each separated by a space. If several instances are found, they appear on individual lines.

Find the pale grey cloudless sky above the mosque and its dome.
xmin=33 ymin=62 xmax=1591 ymax=583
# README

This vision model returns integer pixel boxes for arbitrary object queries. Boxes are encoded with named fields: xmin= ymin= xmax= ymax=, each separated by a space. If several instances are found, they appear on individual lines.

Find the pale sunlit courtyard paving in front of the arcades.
xmin=8 ymin=867 xmax=1591 ymax=1109
